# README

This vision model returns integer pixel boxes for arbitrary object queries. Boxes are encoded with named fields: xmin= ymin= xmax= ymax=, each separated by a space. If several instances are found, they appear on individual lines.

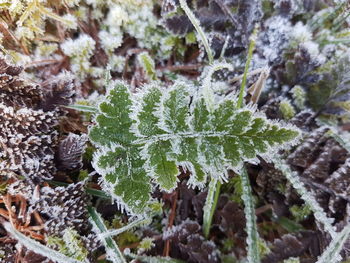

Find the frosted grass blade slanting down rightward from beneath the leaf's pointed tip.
xmin=273 ymin=156 xmax=337 ymax=238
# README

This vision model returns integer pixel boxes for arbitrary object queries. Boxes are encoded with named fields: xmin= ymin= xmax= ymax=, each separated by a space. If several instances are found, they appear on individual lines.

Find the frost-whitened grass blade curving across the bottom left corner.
xmin=3 ymin=222 xmax=89 ymax=263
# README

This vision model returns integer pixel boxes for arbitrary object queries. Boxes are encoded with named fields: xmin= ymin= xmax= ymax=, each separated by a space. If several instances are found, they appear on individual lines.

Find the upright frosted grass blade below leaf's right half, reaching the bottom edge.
xmin=241 ymin=167 xmax=260 ymax=263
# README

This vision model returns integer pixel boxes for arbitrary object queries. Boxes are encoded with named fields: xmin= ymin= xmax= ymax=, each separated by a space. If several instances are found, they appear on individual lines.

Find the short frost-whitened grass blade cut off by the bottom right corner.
xmin=316 ymin=225 xmax=350 ymax=263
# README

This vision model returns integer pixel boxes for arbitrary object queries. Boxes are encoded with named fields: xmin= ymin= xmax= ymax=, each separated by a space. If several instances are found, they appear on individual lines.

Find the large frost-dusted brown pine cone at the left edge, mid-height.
xmin=0 ymin=103 xmax=57 ymax=183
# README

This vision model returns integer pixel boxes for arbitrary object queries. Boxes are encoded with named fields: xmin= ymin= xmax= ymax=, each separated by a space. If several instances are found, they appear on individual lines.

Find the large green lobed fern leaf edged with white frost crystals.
xmin=89 ymin=82 xmax=299 ymax=213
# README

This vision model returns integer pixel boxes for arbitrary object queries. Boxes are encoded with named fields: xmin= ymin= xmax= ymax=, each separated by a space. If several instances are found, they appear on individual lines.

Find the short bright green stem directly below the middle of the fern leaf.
xmin=203 ymin=177 xmax=221 ymax=238
